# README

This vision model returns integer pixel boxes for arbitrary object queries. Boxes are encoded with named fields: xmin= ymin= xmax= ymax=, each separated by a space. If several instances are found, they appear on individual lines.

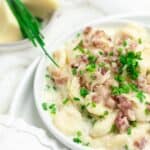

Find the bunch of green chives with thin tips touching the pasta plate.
xmin=6 ymin=0 xmax=58 ymax=67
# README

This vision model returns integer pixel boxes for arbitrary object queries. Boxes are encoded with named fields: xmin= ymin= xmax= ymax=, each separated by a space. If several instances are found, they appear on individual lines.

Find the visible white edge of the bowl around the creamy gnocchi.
xmin=34 ymin=18 xmax=148 ymax=150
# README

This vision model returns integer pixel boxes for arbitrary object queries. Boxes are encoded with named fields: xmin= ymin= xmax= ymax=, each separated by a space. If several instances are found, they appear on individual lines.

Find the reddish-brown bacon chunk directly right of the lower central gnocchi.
xmin=115 ymin=111 xmax=129 ymax=132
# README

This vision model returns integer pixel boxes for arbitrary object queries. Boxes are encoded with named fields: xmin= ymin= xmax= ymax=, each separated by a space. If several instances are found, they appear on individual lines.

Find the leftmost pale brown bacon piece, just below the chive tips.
xmin=52 ymin=71 xmax=68 ymax=85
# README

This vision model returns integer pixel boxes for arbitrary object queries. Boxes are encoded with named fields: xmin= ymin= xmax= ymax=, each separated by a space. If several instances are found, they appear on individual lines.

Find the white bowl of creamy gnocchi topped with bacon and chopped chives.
xmin=34 ymin=19 xmax=150 ymax=150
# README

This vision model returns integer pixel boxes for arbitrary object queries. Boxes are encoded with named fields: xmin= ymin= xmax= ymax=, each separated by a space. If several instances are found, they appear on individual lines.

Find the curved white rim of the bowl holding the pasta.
xmin=33 ymin=15 xmax=150 ymax=150
